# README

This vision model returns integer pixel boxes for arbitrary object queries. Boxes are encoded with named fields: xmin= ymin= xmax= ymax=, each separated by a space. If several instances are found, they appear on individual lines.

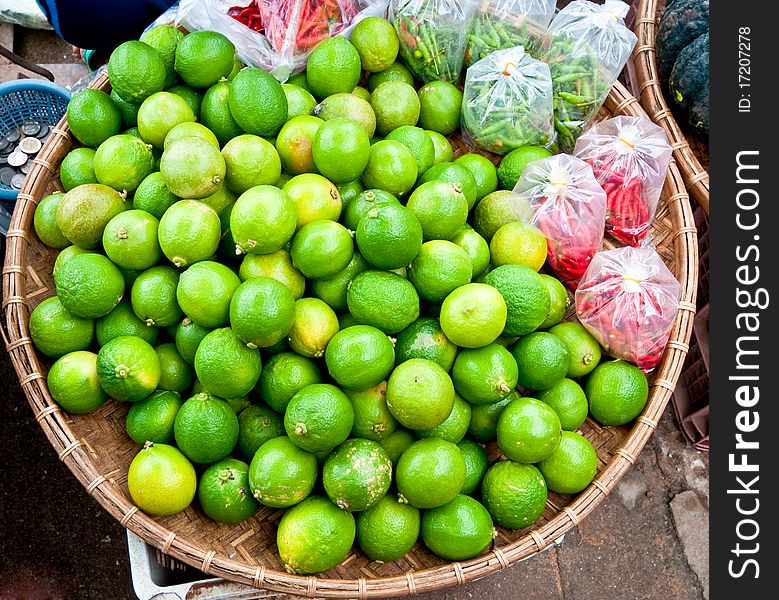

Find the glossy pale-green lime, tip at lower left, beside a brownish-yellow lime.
xmin=230 ymin=185 xmax=297 ymax=254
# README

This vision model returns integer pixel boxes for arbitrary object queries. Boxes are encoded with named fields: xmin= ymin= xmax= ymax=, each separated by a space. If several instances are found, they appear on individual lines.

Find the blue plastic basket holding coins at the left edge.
xmin=0 ymin=79 xmax=70 ymax=201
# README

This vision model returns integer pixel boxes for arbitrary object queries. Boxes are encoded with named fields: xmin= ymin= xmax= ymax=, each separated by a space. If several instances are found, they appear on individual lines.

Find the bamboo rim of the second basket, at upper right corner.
xmin=630 ymin=0 xmax=709 ymax=213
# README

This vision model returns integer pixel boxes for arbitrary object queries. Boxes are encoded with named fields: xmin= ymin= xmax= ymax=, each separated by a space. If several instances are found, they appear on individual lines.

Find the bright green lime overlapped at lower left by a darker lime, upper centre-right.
xmin=407 ymin=181 xmax=468 ymax=241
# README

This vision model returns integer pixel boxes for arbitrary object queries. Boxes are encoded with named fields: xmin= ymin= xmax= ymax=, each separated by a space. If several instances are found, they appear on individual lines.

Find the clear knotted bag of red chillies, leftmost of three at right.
xmin=513 ymin=154 xmax=606 ymax=289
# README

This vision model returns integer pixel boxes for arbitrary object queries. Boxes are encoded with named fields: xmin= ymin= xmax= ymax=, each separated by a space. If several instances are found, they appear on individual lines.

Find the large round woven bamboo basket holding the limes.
xmin=2 ymin=69 xmax=698 ymax=598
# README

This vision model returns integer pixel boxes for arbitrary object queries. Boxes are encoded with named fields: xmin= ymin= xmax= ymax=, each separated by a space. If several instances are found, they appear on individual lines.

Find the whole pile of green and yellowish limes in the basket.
xmin=30 ymin=18 xmax=648 ymax=574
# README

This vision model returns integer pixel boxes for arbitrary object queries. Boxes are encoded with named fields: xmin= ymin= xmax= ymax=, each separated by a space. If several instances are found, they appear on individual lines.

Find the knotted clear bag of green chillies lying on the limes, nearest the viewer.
xmin=462 ymin=46 xmax=554 ymax=154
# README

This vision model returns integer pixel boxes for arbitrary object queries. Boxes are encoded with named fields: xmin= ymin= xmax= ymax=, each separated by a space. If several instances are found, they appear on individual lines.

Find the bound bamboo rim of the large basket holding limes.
xmin=0 ymin=74 xmax=698 ymax=598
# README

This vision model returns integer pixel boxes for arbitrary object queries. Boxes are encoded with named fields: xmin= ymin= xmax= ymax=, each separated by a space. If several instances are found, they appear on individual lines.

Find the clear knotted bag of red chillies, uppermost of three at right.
xmin=574 ymin=116 xmax=672 ymax=246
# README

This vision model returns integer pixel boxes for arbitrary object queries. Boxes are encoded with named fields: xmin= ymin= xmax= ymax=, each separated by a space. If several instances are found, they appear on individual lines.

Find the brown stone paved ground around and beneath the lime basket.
xmin=0 ymin=24 xmax=709 ymax=600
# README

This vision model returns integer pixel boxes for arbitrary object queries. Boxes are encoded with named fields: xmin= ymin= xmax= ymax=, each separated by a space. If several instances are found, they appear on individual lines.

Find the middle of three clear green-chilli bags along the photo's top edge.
xmin=465 ymin=0 xmax=555 ymax=67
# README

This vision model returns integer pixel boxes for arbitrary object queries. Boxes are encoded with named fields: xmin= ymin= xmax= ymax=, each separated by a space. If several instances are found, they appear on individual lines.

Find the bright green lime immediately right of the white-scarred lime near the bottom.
xmin=395 ymin=437 xmax=465 ymax=508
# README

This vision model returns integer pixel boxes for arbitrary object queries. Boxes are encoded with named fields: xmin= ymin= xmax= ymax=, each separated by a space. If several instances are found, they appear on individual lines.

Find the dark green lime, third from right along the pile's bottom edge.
xmin=481 ymin=460 xmax=547 ymax=529
